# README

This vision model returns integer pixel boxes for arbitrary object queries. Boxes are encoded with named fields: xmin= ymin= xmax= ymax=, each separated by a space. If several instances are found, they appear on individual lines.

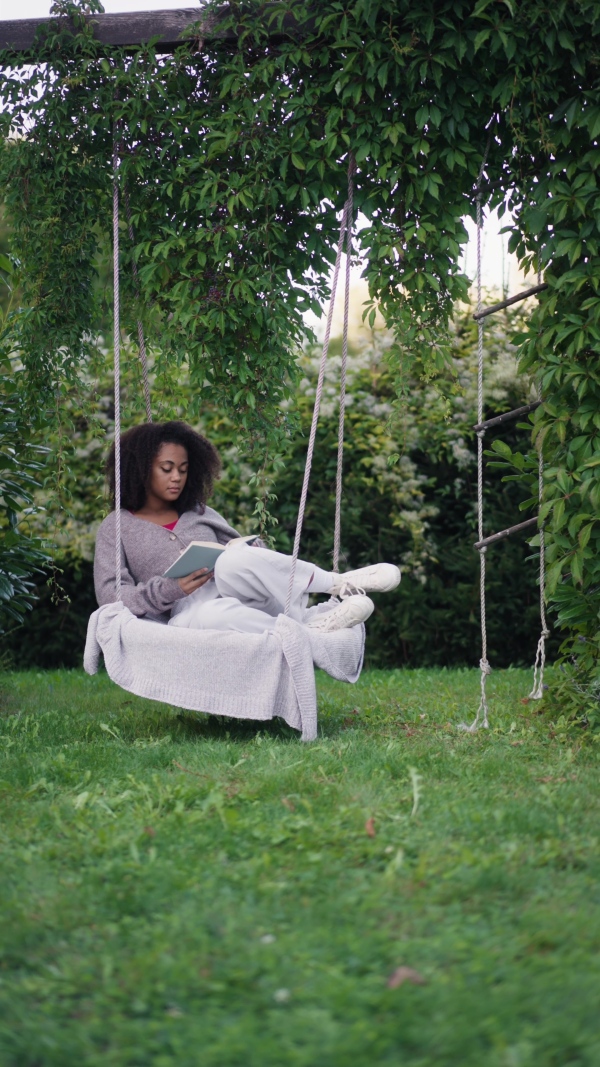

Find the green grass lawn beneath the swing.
xmin=0 ymin=670 xmax=600 ymax=1067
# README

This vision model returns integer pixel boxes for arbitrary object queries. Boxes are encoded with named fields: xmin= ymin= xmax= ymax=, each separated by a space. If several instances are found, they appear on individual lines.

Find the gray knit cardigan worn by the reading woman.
xmin=94 ymin=507 xmax=239 ymax=621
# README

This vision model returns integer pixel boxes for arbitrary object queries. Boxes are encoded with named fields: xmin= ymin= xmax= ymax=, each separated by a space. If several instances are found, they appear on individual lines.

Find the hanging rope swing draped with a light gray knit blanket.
xmin=83 ymin=147 xmax=365 ymax=740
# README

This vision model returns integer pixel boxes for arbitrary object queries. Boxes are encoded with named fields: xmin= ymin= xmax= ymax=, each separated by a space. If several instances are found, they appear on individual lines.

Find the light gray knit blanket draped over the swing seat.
xmin=83 ymin=601 xmax=365 ymax=740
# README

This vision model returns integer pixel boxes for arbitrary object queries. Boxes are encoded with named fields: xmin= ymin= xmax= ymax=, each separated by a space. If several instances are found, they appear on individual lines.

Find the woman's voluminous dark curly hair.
xmin=106 ymin=421 xmax=221 ymax=515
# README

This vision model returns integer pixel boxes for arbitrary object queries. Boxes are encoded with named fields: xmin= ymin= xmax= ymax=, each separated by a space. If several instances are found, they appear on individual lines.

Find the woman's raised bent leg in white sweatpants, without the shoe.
xmin=215 ymin=545 xmax=333 ymax=622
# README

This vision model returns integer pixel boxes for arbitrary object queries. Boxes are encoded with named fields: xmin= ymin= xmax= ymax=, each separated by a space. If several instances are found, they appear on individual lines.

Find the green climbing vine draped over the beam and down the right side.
xmin=0 ymin=0 xmax=600 ymax=687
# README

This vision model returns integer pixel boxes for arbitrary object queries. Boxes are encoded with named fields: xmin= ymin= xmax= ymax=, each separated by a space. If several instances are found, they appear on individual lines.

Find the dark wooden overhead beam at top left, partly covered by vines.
xmin=0 ymin=6 xmax=236 ymax=58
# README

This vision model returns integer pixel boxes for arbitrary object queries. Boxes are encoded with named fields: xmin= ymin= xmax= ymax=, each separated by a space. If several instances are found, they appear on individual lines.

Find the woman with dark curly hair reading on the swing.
xmin=94 ymin=421 xmax=400 ymax=633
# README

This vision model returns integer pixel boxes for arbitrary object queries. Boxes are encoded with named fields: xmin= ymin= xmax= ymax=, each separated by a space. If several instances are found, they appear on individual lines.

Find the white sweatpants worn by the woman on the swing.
xmin=169 ymin=544 xmax=333 ymax=634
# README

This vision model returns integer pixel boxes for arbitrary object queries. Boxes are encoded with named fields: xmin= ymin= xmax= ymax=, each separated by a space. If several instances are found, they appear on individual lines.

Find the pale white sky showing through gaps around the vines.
xmin=0 ymin=0 xmax=525 ymax=332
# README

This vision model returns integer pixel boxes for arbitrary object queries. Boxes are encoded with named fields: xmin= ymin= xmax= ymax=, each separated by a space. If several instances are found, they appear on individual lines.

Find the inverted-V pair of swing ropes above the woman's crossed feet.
xmin=284 ymin=155 xmax=356 ymax=615
